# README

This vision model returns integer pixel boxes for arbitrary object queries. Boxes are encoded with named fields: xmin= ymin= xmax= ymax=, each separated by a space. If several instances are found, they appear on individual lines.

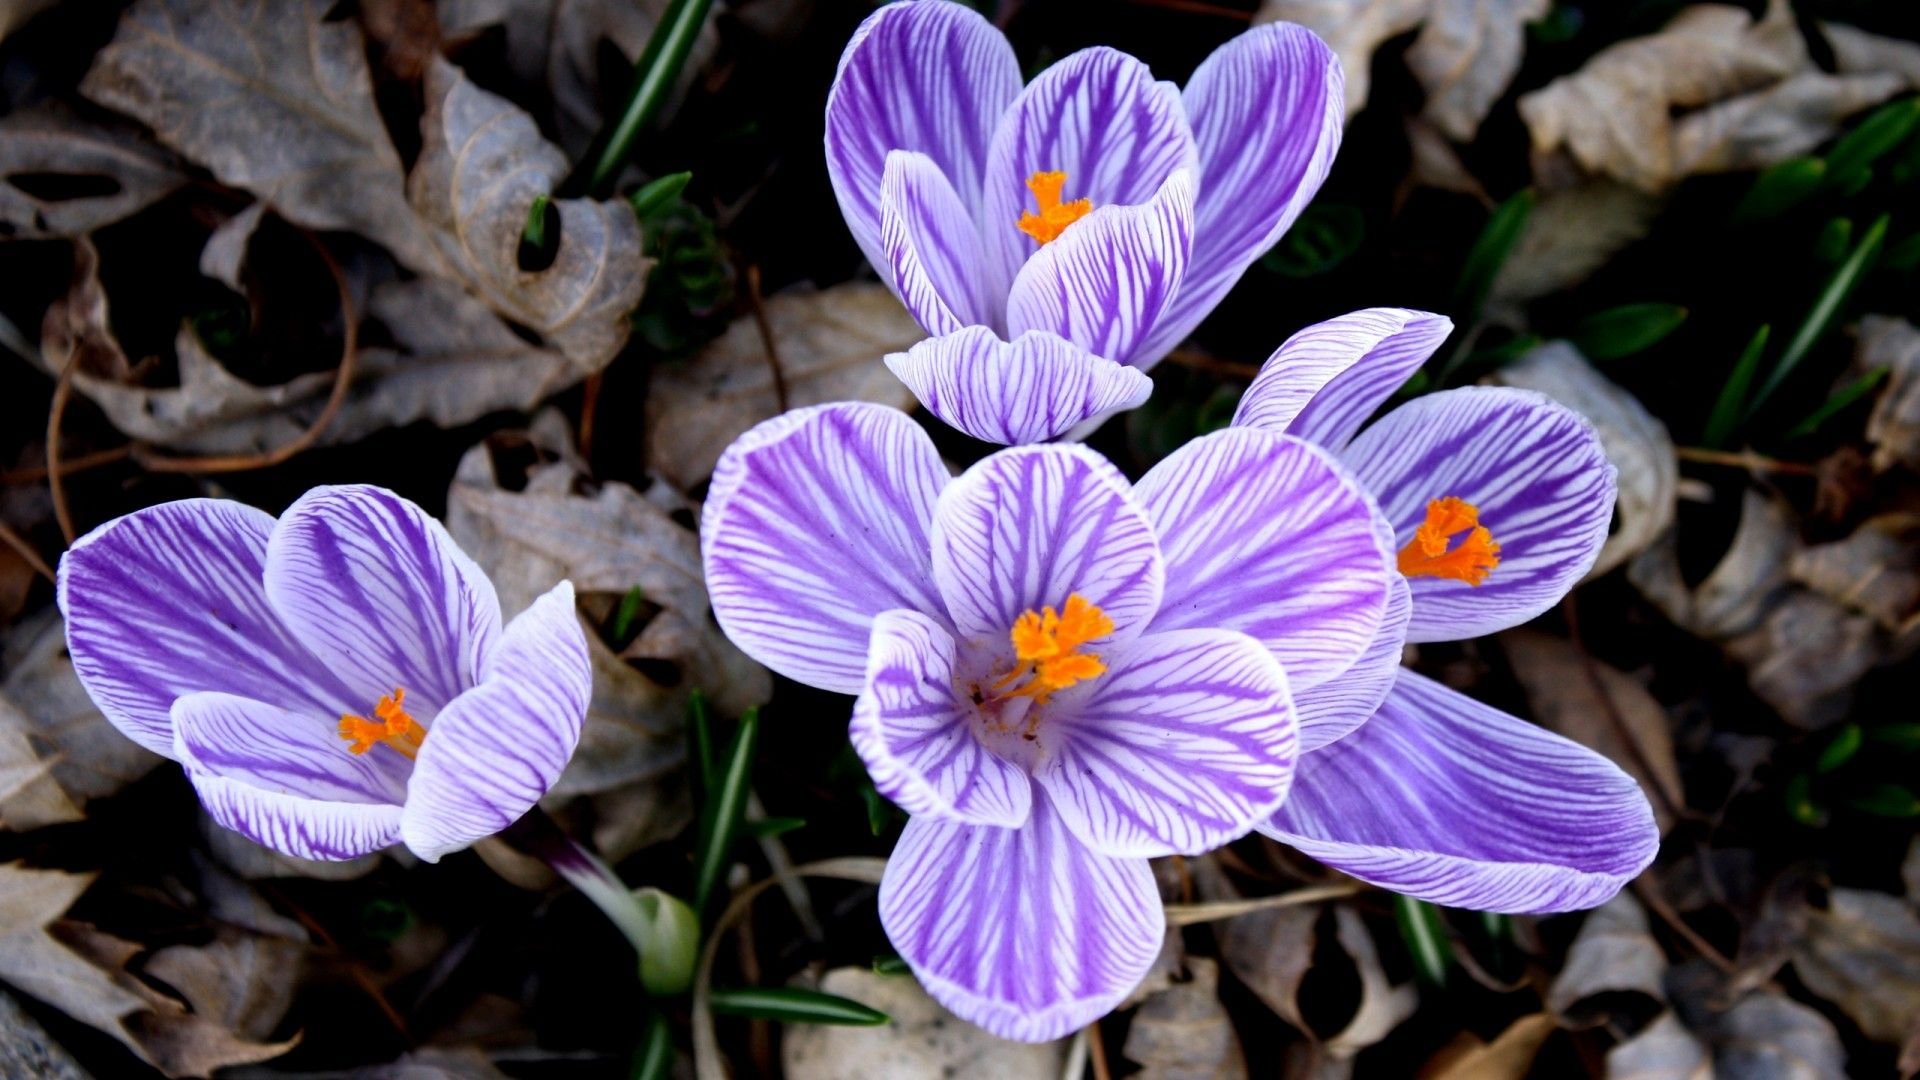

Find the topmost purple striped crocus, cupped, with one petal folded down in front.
xmin=826 ymin=0 xmax=1344 ymax=444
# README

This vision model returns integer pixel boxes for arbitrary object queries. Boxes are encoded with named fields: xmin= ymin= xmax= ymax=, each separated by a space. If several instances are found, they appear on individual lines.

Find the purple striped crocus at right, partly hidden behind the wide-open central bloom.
xmin=1235 ymin=307 xmax=1659 ymax=913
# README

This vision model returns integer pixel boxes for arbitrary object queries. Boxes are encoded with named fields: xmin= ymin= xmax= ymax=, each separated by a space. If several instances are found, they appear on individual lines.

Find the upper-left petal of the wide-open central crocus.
xmin=701 ymin=402 xmax=948 ymax=694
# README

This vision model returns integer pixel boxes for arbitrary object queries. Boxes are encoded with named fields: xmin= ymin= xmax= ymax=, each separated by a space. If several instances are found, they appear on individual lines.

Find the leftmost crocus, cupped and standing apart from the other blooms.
xmin=60 ymin=486 xmax=593 ymax=861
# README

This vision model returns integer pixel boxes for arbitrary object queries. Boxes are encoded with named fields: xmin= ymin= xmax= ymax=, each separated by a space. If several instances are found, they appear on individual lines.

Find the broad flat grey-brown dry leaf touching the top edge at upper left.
xmin=81 ymin=0 xmax=442 ymax=273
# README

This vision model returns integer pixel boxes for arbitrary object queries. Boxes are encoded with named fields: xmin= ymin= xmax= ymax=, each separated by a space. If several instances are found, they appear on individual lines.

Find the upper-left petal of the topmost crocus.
xmin=826 ymin=2 xmax=1020 ymax=267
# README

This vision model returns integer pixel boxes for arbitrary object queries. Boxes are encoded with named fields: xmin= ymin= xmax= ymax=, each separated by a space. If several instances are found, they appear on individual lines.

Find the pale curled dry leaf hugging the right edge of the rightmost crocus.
xmin=1500 ymin=342 xmax=1680 ymax=580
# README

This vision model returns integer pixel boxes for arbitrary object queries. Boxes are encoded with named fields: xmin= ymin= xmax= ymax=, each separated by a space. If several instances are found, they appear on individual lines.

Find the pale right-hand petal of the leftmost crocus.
xmin=401 ymin=580 xmax=593 ymax=863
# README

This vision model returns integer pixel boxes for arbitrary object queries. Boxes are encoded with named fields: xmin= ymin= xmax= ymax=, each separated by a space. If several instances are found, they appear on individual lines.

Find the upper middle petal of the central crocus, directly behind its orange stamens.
xmin=925 ymin=444 xmax=1164 ymax=646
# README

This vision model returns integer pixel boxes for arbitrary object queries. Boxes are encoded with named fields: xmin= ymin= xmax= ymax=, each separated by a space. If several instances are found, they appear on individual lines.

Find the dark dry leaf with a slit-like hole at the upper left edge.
xmin=0 ymin=104 xmax=186 ymax=240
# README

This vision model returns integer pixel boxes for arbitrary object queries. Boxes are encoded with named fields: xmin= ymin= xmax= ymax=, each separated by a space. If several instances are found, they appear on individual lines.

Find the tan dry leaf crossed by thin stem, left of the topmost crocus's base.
xmin=647 ymin=282 xmax=925 ymax=490
